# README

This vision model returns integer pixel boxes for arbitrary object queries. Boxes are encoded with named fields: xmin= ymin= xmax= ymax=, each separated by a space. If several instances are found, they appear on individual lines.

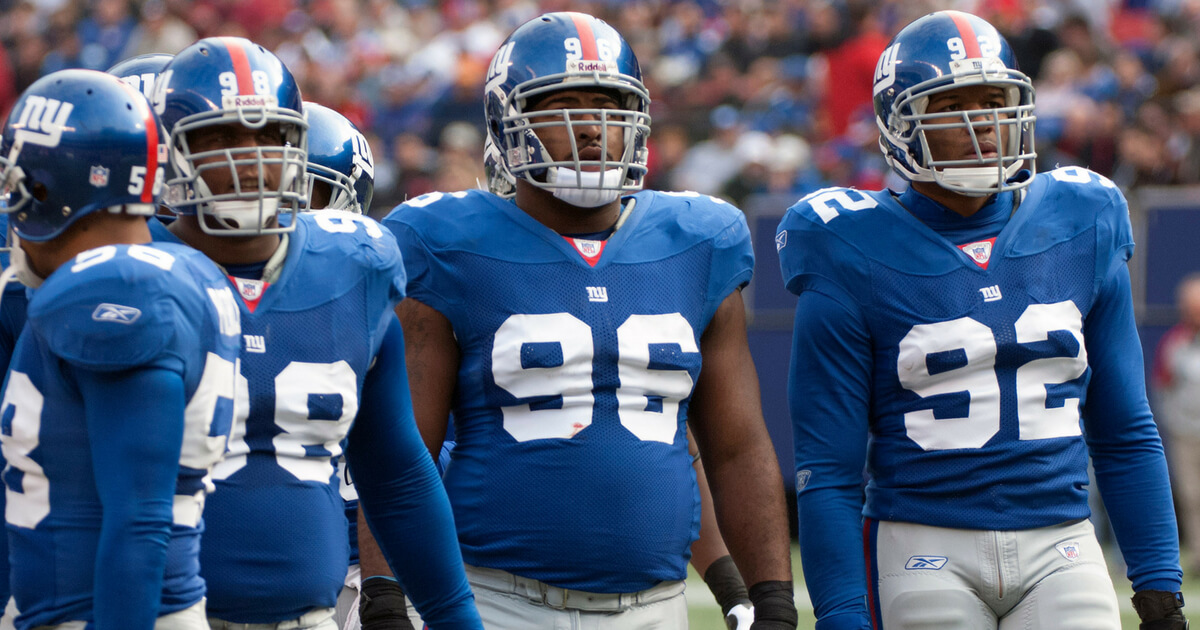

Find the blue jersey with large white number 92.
xmin=776 ymin=168 xmax=1144 ymax=529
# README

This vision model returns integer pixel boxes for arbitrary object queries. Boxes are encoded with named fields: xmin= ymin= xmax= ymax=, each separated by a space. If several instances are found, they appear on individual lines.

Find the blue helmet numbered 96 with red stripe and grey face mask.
xmin=484 ymin=12 xmax=650 ymax=205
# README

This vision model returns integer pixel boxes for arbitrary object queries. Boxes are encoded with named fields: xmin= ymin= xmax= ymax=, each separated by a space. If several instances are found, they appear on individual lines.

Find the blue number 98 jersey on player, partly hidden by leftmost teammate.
xmin=156 ymin=210 xmax=404 ymax=623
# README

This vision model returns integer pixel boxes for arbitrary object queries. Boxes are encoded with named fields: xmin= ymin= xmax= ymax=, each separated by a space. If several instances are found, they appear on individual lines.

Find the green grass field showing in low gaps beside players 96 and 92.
xmin=686 ymin=544 xmax=1200 ymax=630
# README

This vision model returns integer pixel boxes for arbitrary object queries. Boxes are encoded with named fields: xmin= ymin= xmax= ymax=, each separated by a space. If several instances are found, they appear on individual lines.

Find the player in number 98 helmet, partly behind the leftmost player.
xmin=154 ymin=37 xmax=480 ymax=630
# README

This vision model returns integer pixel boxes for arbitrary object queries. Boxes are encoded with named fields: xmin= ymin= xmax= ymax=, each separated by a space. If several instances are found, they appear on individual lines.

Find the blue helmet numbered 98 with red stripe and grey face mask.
xmin=154 ymin=37 xmax=308 ymax=236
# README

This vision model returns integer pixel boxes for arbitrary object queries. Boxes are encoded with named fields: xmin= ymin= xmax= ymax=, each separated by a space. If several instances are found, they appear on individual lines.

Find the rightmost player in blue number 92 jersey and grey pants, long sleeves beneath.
xmin=775 ymin=11 xmax=1187 ymax=630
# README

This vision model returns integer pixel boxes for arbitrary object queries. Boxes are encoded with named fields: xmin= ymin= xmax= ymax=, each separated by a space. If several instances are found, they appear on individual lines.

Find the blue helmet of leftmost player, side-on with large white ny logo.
xmin=0 ymin=70 xmax=167 ymax=241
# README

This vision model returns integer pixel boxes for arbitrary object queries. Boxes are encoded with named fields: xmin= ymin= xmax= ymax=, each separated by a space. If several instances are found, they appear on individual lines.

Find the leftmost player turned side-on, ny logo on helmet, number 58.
xmin=0 ymin=70 xmax=241 ymax=630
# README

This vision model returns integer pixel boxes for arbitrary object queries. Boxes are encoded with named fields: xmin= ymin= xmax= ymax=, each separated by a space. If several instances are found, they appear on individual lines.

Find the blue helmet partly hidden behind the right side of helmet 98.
xmin=304 ymin=101 xmax=374 ymax=214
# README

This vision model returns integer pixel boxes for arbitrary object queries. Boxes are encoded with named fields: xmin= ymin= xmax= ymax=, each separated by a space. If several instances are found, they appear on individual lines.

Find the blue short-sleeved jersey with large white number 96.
xmin=384 ymin=191 xmax=754 ymax=593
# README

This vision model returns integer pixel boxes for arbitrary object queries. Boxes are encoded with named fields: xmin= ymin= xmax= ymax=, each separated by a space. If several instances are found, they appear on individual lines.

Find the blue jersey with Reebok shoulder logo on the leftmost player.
xmin=0 ymin=244 xmax=240 ymax=628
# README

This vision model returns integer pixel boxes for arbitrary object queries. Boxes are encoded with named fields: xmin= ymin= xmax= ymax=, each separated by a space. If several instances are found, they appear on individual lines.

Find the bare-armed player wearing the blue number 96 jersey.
xmin=367 ymin=13 xmax=797 ymax=630
